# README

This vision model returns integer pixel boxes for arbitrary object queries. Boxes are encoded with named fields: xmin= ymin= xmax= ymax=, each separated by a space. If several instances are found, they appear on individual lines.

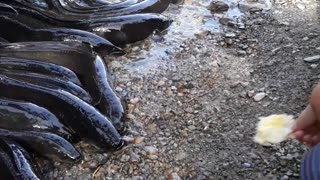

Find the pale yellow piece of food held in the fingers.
xmin=254 ymin=114 xmax=294 ymax=146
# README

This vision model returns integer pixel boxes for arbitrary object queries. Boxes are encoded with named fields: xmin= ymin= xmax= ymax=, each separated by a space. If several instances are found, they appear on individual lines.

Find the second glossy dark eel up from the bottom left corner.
xmin=0 ymin=129 xmax=81 ymax=163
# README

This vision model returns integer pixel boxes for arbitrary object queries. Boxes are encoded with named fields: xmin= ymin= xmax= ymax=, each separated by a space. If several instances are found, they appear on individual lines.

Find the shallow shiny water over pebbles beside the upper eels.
xmin=115 ymin=0 xmax=272 ymax=74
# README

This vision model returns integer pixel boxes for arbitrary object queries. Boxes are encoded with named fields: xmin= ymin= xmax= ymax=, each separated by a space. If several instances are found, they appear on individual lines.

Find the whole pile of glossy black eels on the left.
xmin=0 ymin=0 xmax=172 ymax=180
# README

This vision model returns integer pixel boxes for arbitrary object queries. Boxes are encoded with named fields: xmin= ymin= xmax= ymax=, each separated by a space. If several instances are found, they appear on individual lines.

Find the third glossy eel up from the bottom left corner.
xmin=0 ymin=98 xmax=74 ymax=141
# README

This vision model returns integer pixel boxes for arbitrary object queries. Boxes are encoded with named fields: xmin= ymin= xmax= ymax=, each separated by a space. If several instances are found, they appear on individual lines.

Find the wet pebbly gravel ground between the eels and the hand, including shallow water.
xmin=47 ymin=0 xmax=320 ymax=180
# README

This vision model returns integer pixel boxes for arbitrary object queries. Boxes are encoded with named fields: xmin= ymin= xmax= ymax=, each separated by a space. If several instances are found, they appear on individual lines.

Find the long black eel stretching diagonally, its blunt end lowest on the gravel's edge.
xmin=0 ymin=75 xmax=124 ymax=150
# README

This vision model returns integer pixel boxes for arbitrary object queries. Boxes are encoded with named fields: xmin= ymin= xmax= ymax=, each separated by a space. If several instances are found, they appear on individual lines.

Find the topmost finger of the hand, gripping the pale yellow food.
xmin=293 ymin=105 xmax=316 ymax=132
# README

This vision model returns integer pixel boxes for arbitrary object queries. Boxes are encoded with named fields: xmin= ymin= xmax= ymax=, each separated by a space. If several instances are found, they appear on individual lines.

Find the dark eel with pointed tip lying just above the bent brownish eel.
xmin=0 ymin=16 xmax=125 ymax=56
